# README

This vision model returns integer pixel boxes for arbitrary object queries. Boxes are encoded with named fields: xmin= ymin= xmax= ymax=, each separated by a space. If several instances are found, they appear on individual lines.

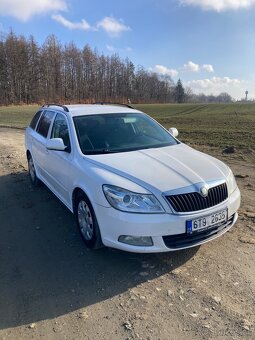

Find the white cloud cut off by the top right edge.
xmin=179 ymin=0 xmax=255 ymax=12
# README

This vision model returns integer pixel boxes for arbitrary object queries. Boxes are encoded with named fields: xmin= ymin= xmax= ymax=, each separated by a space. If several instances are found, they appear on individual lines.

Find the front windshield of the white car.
xmin=73 ymin=113 xmax=178 ymax=155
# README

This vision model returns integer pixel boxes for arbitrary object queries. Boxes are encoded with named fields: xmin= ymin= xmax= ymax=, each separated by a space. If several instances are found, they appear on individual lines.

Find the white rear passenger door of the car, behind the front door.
xmin=31 ymin=110 xmax=55 ymax=184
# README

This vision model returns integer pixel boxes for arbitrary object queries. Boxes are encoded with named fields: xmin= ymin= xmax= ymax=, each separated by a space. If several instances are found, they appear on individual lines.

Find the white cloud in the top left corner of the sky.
xmin=0 ymin=0 xmax=67 ymax=21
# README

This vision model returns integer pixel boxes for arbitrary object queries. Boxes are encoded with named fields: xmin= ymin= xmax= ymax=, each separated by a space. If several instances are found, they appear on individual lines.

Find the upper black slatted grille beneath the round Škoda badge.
xmin=166 ymin=183 xmax=228 ymax=212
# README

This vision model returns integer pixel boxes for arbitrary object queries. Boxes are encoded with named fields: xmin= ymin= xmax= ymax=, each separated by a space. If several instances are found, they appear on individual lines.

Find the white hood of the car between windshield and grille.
xmin=86 ymin=143 xmax=229 ymax=192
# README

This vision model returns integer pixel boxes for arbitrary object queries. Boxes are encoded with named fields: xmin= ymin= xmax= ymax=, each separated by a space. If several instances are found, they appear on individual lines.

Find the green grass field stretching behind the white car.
xmin=0 ymin=103 xmax=255 ymax=148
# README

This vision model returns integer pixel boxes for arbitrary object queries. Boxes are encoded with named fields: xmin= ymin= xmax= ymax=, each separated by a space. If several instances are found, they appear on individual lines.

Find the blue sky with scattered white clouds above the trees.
xmin=0 ymin=0 xmax=255 ymax=100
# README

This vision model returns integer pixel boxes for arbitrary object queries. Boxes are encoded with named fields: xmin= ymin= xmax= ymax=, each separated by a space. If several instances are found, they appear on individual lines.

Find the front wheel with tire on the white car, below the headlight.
xmin=75 ymin=193 xmax=103 ymax=249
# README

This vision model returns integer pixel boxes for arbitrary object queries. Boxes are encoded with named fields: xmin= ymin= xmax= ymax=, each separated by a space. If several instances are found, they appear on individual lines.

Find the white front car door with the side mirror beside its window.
xmin=42 ymin=113 xmax=73 ymax=206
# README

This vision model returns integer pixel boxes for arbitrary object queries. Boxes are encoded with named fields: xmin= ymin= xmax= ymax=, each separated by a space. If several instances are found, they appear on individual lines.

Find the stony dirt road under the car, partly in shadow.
xmin=0 ymin=128 xmax=255 ymax=340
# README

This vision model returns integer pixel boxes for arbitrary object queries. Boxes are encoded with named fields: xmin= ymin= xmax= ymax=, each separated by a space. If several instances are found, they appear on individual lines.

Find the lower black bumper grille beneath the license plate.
xmin=163 ymin=215 xmax=235 ymax=249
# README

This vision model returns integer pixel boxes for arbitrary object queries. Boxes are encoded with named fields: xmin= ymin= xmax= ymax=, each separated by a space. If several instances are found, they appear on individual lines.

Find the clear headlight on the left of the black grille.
xmin=103 ymin=185 xmax=165 ymax=214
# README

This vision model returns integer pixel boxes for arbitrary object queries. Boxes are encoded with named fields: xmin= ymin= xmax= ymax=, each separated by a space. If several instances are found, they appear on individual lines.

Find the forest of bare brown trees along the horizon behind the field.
xmin=0 ymin=31 xmax=233 ymax=105
